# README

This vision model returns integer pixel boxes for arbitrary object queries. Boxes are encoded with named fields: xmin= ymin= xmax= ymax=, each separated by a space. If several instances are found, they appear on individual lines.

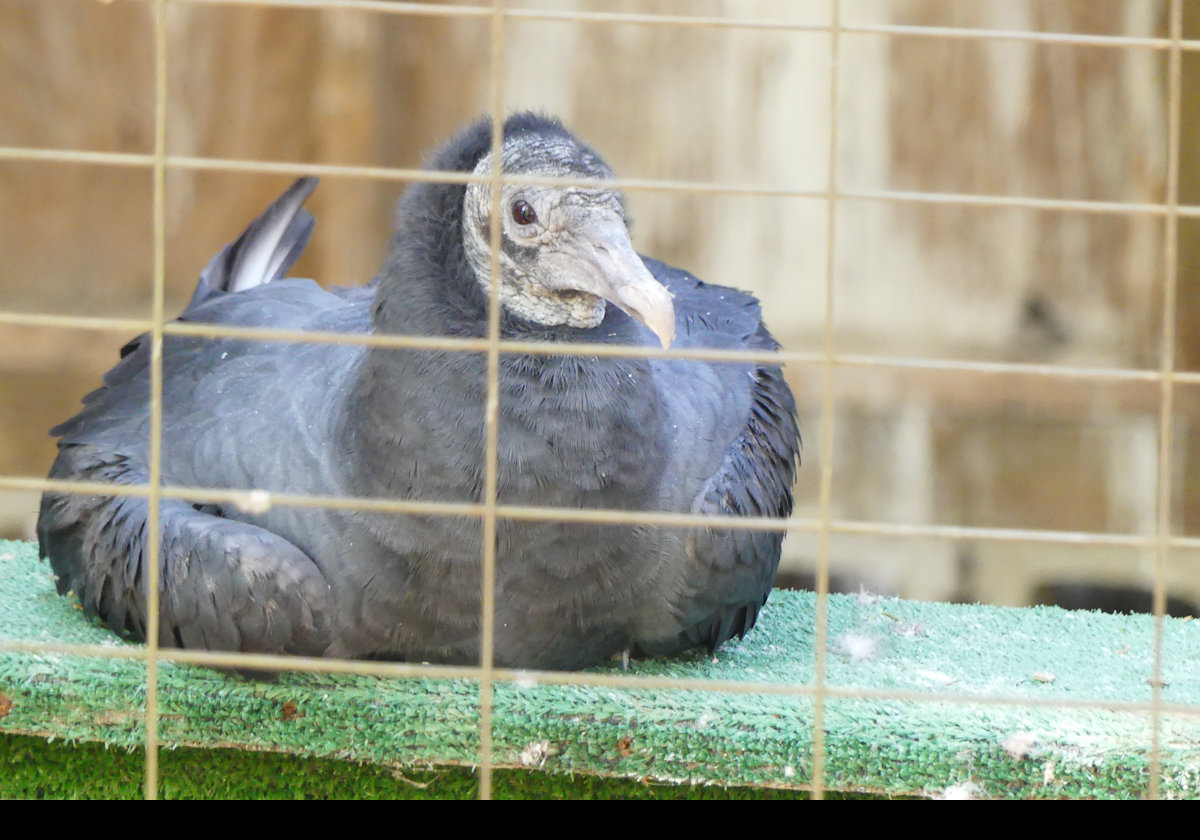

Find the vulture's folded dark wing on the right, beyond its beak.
xmin=642 ymin=259 xmax=800 ymax=655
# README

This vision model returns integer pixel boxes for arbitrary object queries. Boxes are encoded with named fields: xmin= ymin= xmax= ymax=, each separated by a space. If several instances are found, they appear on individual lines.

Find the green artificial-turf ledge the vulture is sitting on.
xmin=0 ymin=542 xmax=1200 ymax=798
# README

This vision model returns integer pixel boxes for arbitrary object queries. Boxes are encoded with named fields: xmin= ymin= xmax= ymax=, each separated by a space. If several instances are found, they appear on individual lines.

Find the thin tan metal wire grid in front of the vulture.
xmin=0 ymin=0 xmax=1200 ymax=799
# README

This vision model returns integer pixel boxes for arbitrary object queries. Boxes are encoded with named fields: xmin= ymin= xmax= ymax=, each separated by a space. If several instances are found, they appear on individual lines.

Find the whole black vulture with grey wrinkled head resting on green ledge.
xmin=38 ymin=114 xmax=800 ymax=668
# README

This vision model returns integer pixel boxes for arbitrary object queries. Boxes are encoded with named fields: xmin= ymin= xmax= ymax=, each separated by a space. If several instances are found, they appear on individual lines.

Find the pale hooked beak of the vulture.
xmin=554 ymin=217 xmax=674 ymax=347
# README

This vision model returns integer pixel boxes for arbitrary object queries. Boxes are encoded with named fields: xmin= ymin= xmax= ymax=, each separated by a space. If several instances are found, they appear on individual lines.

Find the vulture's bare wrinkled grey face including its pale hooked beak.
xmin=462 ymin=136 xmax=674 ymax=347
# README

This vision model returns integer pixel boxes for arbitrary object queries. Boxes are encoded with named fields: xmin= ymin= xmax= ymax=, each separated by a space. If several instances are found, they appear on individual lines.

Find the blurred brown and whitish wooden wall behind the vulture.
xmin=0 ymin=0 xmax=1200 ymax=602
